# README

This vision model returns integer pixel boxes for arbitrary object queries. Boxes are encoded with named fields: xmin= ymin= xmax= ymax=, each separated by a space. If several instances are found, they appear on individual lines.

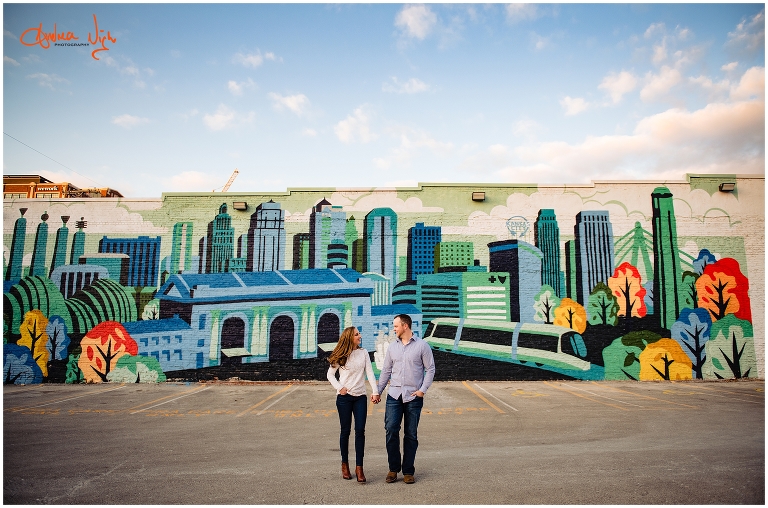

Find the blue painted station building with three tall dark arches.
xmin=157 ymin=269 xmax=375 ymax=366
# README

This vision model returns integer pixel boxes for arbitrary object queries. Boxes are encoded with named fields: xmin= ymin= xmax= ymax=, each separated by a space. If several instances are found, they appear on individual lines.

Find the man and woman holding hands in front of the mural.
xmin=328 ymin=314 xmax=435 ymax=483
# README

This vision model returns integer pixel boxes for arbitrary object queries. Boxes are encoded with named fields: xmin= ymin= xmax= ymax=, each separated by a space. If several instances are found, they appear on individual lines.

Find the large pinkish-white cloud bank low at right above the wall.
xmin=484 ymin=93 xmax=765 ymax=183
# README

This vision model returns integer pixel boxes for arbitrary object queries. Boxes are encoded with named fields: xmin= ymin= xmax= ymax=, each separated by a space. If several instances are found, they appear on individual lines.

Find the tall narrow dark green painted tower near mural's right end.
xmin=644 ymin=187 xmax=681 ymax=329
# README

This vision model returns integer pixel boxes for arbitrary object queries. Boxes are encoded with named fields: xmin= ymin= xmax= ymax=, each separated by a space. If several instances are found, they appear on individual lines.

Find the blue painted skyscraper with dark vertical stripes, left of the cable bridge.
xmin=573 ymin=210 xmax=613 ymax=305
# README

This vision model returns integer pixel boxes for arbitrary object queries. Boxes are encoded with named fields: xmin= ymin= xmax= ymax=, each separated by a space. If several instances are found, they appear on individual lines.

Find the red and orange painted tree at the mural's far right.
xmin=696 ymin=258 xmax=752 ymax=323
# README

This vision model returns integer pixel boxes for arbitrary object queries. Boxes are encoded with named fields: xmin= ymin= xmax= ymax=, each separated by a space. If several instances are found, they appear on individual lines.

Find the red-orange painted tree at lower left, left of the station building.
xmin=78 ymin=321 xmax=139 ymax=383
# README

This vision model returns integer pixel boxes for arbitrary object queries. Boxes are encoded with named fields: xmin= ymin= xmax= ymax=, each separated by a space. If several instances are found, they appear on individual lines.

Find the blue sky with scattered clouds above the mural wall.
xmin=3 ymin=3 xmax=765 ymax=198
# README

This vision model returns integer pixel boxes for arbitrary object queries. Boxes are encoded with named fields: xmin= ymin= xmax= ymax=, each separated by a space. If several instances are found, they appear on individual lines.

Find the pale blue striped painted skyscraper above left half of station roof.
xmin=245 ymin=199 xmax=285 ymax=272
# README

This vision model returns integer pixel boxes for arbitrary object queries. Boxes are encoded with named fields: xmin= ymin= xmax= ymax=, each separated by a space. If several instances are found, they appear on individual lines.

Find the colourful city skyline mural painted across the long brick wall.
xmin=3 ymin=175 xmax=765 ymax=384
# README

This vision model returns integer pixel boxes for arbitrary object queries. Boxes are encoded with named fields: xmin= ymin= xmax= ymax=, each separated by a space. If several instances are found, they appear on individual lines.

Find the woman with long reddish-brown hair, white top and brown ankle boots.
xmin=328 ymin=326 xmax=379 ymax=483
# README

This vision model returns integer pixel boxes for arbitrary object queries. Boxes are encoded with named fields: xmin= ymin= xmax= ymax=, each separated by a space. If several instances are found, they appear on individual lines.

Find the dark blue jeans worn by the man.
xmin=384 ymin=395 xmax=424 ymax=475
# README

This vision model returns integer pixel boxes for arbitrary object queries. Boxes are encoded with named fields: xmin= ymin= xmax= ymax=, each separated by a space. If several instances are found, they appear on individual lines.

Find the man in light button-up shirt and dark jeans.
xmin=371 ymin=314 xmax=435 ymax=483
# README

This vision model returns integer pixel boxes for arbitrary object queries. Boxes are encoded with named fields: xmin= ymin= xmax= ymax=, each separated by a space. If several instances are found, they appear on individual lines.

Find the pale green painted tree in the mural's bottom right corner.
xmin=702 ymin=314 xmax=757 ymax=379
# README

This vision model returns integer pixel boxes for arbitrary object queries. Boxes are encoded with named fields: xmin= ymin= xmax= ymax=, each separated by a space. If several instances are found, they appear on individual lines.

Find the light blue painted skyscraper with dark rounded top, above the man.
xmin=363 ymin=208 xmax=397 ymax=286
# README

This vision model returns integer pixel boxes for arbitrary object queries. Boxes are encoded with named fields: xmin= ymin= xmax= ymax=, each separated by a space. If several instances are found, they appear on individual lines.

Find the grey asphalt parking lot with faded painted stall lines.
xmin=3 ymin=381 xmax=765 ymax=504
